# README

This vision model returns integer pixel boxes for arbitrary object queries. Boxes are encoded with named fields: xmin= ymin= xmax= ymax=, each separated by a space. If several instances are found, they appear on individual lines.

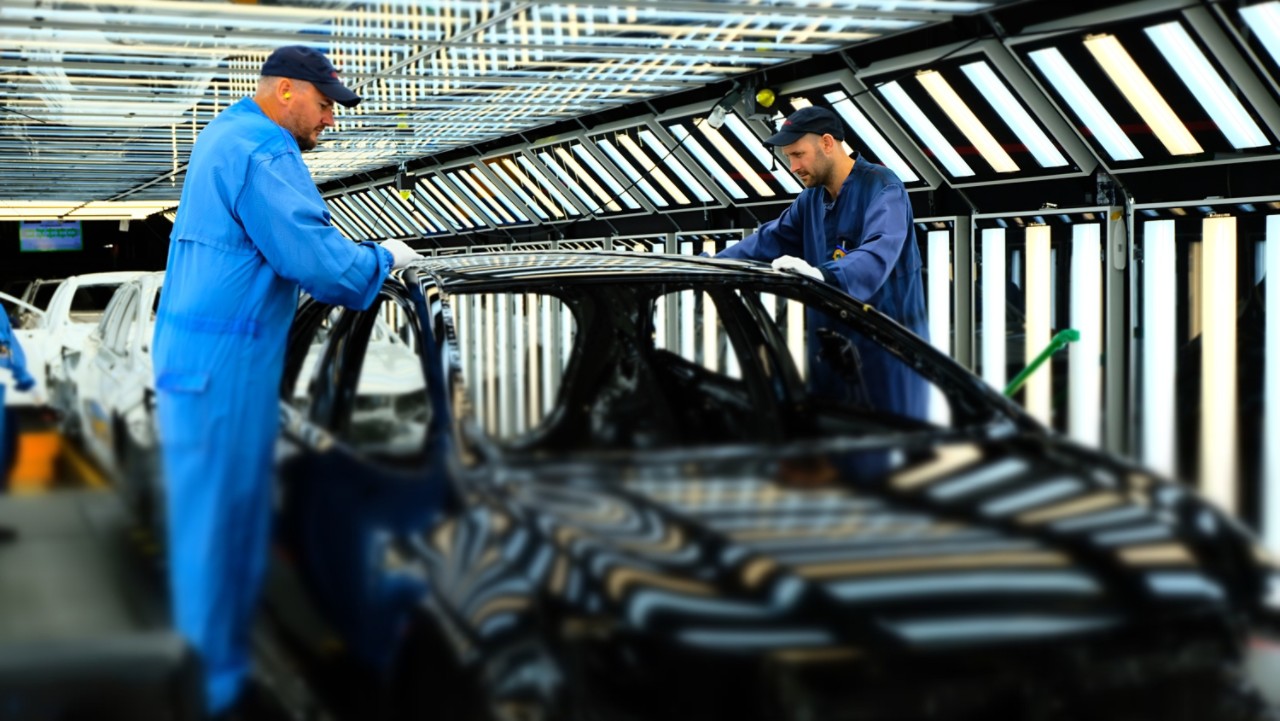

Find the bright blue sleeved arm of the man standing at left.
xmin=237 ymin=154 xmax=393 ymax=310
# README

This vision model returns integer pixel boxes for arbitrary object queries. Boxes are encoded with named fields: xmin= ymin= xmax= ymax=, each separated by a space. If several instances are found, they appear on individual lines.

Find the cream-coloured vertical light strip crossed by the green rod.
xmin=1023 ymin=225 xmax=1053 ymax=425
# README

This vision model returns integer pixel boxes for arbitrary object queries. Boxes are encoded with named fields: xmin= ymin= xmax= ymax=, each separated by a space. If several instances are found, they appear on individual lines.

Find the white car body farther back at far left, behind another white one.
xmin=5 ymin=270 xmax=145 ymax=412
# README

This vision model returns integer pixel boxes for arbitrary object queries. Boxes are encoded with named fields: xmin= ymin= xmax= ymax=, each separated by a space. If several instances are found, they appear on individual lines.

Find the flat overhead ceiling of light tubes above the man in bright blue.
xmin=0 ymin=0 xmax=1004 ymax=216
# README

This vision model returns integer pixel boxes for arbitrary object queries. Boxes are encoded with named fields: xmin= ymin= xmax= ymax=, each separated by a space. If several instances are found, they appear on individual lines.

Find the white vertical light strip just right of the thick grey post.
xmin=1140 ymin=220 xmax=1172 ymax=478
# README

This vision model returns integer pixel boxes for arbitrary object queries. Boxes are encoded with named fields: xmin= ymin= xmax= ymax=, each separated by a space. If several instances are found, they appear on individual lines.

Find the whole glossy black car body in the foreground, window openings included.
xmin=270 ymin=252 xmax=1272 ymax=720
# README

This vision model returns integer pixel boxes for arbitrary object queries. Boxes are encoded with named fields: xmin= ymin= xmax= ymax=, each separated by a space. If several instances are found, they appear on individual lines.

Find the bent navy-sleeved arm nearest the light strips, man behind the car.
xmin=819 ymin=186 xmax=911 ymax=300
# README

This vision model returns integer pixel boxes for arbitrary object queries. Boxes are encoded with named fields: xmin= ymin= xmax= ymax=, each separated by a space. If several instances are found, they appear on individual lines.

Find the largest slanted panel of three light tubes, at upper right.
xmin=1014 ymin=13 xmax=1276 ymax=169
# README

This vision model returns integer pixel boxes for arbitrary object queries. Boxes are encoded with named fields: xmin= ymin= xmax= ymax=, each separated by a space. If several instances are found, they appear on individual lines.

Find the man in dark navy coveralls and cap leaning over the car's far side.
xmin=717 ymin=106 xmax=928 ymax=419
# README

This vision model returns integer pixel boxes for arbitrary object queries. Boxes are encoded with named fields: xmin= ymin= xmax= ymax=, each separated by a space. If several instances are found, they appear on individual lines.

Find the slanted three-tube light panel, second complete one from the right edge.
xmin=859 ymin=50 xmax=1080 ymax=186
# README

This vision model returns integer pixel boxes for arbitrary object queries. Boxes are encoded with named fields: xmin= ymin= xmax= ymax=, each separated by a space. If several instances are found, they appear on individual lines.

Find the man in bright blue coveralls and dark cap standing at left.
xmin=154 ymin=46 xmax=419 ymax=717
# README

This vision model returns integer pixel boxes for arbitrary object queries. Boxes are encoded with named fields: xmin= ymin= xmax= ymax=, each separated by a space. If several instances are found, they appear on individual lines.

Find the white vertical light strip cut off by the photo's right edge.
xmin=1262 ymin=213 xmax=1280 ymax=558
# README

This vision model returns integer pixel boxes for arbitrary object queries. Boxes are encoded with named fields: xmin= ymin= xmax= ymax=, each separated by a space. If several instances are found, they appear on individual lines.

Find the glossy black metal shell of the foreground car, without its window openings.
xmin=275 ymin=254 xmax=1270 ymax=718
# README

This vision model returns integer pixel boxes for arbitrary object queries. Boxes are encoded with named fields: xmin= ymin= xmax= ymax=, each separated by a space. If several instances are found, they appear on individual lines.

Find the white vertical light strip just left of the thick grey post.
xmin=1066 ymin=223 xmax=1105 ymax=448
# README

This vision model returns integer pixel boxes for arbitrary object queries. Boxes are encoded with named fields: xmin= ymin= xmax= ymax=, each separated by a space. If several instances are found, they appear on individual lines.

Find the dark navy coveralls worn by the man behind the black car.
xmin=717 ymin=155 xmax=929 ymax=419
